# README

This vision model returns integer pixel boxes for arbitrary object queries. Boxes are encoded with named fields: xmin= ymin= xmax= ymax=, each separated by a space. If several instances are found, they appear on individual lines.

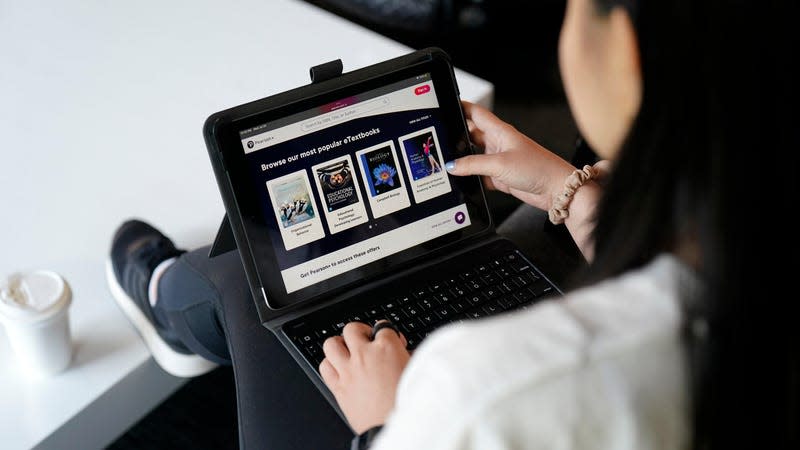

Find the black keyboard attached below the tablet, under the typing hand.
xmin=284 ymin=246 xmax=558 ymax=370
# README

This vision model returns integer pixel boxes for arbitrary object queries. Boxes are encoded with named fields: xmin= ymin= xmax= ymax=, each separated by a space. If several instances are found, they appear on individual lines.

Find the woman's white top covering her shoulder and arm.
xmin=378 ymin=258 xmax=684 ymax=448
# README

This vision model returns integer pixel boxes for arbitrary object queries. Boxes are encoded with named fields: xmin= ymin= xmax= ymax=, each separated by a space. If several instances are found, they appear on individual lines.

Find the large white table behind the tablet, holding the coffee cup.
xmin=0 ymin=0 xmax=493 ymax=449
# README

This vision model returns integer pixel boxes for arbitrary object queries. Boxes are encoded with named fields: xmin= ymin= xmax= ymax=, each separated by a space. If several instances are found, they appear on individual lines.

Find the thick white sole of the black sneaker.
xmin=106 ymin=260 xmax=218 ymax=378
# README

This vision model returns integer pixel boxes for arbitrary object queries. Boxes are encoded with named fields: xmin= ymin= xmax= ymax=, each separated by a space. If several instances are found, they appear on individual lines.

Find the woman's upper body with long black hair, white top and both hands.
xmin=320 ymin=0 xmax=800 ymax=449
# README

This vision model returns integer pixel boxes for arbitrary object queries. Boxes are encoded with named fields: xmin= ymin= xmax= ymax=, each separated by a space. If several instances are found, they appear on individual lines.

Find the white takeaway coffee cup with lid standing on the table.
xmin=0 ymin=270 xmax=72 ymax=376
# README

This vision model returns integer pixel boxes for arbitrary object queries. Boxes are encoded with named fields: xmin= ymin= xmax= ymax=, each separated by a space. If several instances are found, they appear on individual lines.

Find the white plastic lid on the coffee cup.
xmin=0 ymin=270 xmax=72 ymax=323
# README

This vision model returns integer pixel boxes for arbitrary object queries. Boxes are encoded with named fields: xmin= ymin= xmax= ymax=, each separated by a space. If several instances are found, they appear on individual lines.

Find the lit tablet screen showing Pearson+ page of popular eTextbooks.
xmin=240 ymin=74 xmax=470 ymax=293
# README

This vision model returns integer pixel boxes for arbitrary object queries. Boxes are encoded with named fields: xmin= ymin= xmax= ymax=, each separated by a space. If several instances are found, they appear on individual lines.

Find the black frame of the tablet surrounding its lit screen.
xmin=205 ymin=49 xmax=492 ymax=321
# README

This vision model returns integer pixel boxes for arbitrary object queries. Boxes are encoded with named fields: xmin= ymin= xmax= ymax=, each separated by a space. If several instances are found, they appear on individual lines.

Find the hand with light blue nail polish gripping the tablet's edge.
xmin=447 ymin=101 xmax=575 ymax=210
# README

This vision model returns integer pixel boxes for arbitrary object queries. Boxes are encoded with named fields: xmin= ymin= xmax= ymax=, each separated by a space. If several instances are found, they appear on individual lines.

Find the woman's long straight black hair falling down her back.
xmin=584 ymin=0 xmax=800 ymax=449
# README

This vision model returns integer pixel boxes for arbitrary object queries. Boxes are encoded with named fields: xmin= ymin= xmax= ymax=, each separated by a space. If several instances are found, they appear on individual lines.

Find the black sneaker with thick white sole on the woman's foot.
xmin=106 ymin=220 xmax=217 ymax=377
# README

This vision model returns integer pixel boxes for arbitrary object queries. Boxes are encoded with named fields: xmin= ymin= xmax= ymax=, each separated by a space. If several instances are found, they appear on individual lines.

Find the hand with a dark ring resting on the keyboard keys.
xmin=319 ymin=322 xmax=411 ymax=434
